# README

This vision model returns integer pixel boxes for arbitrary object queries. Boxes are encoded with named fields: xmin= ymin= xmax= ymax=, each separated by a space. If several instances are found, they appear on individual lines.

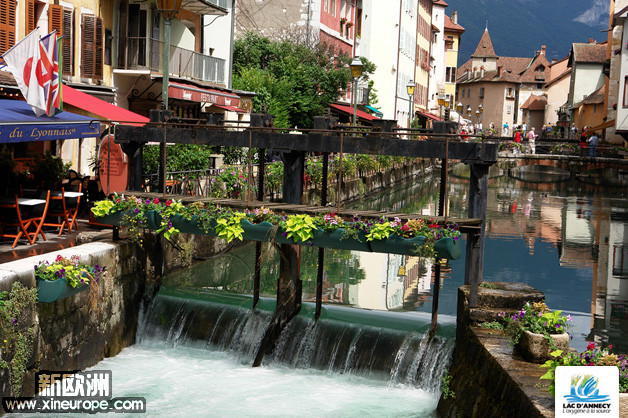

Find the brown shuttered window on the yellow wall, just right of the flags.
xmin=81 ymin=14 xmax=104 ymax=80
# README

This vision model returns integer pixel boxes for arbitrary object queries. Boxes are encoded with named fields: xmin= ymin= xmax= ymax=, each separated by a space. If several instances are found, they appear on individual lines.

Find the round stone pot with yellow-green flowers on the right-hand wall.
xmin=500 ymin=302 xmax=571 ymax=363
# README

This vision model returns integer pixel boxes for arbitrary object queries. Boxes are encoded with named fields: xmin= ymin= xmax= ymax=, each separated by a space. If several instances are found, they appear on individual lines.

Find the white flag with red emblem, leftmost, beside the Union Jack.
xmin=2 ymin=30 xmax=46 ymax=116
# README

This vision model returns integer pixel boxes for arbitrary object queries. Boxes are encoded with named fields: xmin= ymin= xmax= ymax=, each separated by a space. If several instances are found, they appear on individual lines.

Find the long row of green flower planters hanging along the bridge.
xmin=92 ymin=196 xmax=461 ymax=259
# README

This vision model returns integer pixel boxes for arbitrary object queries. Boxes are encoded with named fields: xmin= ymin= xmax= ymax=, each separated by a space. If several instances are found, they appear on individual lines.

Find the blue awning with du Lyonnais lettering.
xmin=0 ymin=100 xmax=100 ymax=144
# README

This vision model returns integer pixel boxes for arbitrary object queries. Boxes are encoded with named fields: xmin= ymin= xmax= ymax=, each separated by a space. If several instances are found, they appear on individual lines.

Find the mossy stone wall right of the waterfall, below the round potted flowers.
xmin=438 ymin=282 xmax=554 ymax=417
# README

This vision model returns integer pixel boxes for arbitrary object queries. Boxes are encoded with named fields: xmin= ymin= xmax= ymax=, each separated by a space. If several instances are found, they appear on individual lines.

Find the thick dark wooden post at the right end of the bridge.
xmin=464 ymin=164 xmax=490 ymax=307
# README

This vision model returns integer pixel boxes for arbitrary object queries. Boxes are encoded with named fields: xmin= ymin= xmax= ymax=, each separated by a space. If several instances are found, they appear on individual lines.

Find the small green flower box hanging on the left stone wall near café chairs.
xmin=35 ymin=255 xmax=104 ymax=303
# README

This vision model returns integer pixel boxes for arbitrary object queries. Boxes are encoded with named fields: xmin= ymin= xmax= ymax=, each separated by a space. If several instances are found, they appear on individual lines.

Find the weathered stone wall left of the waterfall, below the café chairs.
xmin=0 ymin=238 xmax=153 ymax=397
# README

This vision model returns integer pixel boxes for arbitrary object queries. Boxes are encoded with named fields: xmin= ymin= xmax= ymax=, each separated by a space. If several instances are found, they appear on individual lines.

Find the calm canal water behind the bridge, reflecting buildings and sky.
xmin=168 ymin=170 xmax=628 ymax=352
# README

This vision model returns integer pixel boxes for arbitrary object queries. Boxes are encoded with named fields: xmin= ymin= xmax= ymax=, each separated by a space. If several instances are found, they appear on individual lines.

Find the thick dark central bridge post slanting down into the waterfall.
xmin=253 ymin=147 xmax=305 ymax=367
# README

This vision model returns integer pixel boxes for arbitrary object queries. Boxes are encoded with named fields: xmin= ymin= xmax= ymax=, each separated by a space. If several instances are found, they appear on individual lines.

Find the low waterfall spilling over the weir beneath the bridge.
xmin=137 ymin=292 xmax=453 ymax=391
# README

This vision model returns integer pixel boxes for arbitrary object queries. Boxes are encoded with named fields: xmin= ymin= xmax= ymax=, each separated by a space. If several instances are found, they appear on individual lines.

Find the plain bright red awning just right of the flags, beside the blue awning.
xmin=62 ymin=84 xmax=149 ymax=125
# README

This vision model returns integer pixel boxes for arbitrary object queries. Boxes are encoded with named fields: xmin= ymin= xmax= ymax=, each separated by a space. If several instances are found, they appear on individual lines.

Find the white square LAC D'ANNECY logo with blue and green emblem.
xmin=555 ymin=366 xmax=619 ymax=418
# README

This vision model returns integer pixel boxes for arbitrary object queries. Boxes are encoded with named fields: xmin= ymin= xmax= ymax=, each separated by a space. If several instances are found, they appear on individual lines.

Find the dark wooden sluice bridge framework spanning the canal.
xmin=110 ymin=111 xmax=498 ymax=366
